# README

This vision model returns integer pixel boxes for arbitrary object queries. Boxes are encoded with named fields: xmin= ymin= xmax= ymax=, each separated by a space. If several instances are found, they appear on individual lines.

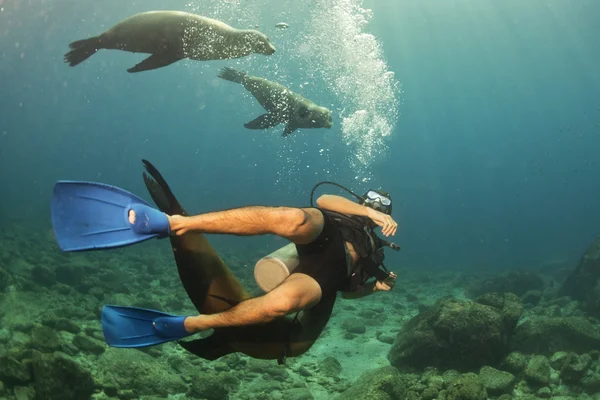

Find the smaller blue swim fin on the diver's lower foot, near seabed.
xmin=102 ymin=305 xmax=193 ymax=347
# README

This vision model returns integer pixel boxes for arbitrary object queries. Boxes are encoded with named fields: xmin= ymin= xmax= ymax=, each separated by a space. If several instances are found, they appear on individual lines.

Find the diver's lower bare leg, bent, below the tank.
xmin=184 ymin=273 xmax=321 ymax=332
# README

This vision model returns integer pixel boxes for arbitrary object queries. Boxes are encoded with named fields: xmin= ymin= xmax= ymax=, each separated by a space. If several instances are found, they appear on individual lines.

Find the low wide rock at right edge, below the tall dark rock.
xmin=511 ymin=317 xmax=600 ymax=356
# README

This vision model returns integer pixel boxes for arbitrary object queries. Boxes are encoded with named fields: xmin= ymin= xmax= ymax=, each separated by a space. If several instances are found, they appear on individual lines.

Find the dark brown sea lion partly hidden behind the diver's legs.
xmin=142 ymin=160 xmax=336 ymax=363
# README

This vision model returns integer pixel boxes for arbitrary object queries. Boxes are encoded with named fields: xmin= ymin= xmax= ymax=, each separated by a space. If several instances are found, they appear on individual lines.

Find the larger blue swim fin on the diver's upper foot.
xmin=51 ymin=181 xmax=170 ymax=251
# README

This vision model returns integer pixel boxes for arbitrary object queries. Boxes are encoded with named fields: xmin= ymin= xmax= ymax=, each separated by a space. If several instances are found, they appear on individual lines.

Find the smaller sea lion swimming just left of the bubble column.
xmin=219 ymin=67 xmax=332 ymax=136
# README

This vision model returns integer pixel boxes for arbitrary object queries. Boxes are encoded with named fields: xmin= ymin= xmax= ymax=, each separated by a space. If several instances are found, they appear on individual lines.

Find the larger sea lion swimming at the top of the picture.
xmin=65 ymin=11 xmax=275 ymax=72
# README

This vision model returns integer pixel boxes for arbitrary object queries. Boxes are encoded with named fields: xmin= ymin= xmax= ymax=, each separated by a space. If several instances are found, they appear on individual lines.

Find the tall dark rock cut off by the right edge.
xmin=560 ymin=236 xmax=600 ymax=316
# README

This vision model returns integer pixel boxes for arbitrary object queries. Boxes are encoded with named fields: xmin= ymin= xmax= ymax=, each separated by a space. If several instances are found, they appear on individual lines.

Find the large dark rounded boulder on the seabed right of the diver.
xmin=388 ymin=297 xmax=510 ymax=371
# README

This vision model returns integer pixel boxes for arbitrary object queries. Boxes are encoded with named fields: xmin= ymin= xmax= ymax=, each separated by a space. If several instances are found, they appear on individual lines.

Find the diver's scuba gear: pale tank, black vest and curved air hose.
xmin=254 ymin=181 xmax=400 ymax=292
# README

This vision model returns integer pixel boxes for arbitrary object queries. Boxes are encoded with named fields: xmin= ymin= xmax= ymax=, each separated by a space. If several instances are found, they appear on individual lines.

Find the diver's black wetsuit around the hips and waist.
xmin=292 ymin=212 xmax=348 ymax=298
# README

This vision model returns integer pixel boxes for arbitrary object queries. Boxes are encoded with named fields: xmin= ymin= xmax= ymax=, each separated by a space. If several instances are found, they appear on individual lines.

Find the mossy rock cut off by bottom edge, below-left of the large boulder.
xmin=336 ymin=366 xmax=406 ymax=400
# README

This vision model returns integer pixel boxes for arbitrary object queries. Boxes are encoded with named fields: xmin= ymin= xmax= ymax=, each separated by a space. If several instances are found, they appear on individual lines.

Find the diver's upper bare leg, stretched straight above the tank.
xmin=169 ymin=206 xmax=307 ymax=237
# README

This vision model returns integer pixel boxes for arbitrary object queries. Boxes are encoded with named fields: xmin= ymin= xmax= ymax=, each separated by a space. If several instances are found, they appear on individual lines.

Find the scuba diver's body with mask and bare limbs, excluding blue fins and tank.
xmin=165 ymin=181 xmax=398 ymax=332
